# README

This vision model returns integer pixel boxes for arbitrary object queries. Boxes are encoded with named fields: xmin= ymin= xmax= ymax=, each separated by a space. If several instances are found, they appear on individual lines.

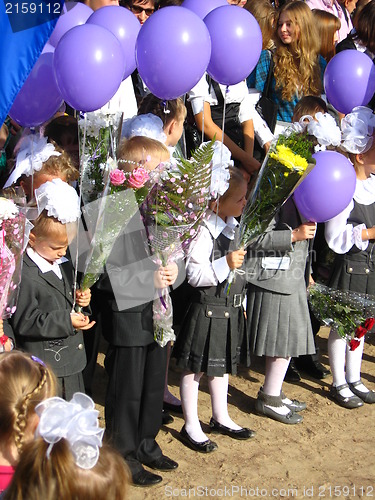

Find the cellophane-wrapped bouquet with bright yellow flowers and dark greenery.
xmin=227 ymin=130 xmax=315 ymax=293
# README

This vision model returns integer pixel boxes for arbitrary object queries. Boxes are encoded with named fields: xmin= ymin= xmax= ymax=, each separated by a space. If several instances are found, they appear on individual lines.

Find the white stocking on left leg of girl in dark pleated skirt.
xmin=180 ymin=372 xmax=208 ymax=443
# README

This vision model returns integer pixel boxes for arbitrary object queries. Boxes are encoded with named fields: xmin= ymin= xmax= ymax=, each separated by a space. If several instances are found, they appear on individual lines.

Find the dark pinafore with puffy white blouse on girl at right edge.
xmin=325 ymin=175 xmax=375 ymax=295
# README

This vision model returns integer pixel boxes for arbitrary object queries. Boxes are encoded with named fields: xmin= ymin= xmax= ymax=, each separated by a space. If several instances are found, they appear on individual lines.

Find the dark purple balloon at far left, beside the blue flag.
xmin=9 ymin=52 xmax=63 ymax=127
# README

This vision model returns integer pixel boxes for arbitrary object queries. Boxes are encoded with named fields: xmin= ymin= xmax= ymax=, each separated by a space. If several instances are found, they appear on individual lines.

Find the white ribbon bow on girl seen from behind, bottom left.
xmin=35 ymin=392 xmax=104 ymax=469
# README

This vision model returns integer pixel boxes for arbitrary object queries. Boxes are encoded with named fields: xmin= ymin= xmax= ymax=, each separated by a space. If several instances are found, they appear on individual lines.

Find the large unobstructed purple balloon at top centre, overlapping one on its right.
xmin=136 ymin=6 xmax=211 ymax=99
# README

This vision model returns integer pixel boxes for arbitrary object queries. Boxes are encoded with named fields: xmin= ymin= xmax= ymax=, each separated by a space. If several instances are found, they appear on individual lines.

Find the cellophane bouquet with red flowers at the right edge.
xmin=308 ymin=283 xmax=375 ymax=351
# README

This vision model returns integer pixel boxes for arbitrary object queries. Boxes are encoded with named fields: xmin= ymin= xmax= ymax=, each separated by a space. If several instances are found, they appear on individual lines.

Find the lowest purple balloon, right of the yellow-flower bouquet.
xmin=294 ymin=151 xmax=356 ymax=222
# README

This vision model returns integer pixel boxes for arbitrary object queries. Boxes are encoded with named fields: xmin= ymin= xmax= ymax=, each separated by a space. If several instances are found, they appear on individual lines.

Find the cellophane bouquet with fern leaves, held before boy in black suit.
xmin=140 ymin=141 xmax=214 ymax=347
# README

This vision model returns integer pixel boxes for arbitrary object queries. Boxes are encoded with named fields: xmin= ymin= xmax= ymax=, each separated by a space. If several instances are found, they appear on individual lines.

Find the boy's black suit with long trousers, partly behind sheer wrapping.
xmin=98 ymin=214 xmax=167 ymax=476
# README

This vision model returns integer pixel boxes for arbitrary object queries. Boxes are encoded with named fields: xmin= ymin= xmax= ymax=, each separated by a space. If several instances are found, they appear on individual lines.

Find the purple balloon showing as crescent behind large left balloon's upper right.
xmin=87 ymin=5 xmax=141 ymax=79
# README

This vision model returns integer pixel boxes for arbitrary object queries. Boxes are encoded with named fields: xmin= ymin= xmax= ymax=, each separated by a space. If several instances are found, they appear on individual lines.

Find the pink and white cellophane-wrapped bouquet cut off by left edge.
xmin=0 ymin=196 xmax=26 ymax=319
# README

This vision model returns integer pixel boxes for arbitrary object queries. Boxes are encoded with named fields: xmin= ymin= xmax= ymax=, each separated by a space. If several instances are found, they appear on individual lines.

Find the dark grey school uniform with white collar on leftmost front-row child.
xmin=9 ymin=248 xmax=86 ymax=400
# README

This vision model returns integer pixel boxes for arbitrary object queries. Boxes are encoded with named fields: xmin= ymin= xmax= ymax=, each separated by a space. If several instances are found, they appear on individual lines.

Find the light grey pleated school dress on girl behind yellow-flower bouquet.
xmin=246 ymin=199 xmax=315 ymax=358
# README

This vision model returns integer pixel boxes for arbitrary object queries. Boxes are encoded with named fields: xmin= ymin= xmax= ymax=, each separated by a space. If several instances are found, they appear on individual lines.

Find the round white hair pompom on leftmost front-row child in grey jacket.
xmin=35 ymin=178 xmax=81 ymax=224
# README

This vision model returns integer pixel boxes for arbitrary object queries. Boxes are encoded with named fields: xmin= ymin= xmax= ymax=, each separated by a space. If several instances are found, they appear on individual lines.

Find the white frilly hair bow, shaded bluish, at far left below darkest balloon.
xmin=4 ymin=134 xmax=61 ymax=188
